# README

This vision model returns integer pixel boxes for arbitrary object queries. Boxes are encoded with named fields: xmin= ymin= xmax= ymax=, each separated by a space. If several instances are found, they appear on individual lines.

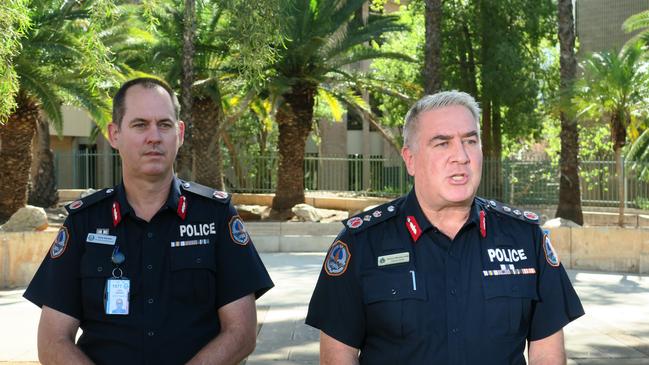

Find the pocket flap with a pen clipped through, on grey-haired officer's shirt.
xmin=362 ymin=271 xmax=427 ymax=304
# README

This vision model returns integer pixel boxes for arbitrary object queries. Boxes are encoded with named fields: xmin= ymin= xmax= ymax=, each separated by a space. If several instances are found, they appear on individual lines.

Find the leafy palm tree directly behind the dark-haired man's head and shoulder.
xmin=128 ymin=0 xmax=281 ymax=189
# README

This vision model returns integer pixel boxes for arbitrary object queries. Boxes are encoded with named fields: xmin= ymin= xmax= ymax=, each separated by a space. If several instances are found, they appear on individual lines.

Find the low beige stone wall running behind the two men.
xmin=0 ymin=222 xmax=649 ymax=288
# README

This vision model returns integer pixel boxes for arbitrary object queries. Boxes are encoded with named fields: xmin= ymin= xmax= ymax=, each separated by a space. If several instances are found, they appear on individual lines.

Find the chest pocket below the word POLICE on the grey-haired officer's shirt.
xmin=483 ymin=275 xmax=538 ymax=339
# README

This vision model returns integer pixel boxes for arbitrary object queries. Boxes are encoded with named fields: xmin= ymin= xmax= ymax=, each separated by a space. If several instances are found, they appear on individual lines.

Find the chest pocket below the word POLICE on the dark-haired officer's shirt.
xmin=170 ymin=244 xmax=216 ymax=307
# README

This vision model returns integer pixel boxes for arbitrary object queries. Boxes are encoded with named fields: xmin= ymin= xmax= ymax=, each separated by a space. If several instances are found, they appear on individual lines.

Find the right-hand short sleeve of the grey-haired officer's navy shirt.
xmin=529 ymin=227 xmax=584 ymax=341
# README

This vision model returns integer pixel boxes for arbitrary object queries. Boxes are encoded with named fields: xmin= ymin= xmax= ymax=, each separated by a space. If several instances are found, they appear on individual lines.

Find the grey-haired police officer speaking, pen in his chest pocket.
xmin=306 ymin=91 xmax=584 ymax=365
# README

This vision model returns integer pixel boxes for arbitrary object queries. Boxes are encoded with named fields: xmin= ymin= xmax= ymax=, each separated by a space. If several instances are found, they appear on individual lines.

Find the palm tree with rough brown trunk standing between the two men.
xmin=267 ymin=0 xmax=405 ymax=212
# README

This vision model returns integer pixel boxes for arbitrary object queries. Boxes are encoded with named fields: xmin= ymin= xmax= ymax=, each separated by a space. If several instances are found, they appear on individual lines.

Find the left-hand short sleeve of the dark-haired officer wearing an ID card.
xmin=23 ymin=217 xmax=83 ymax=319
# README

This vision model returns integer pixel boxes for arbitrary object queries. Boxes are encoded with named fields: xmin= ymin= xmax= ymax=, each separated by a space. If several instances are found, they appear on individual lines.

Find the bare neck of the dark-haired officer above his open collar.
xmin=123 ymin=173 xmax=173 ymax=222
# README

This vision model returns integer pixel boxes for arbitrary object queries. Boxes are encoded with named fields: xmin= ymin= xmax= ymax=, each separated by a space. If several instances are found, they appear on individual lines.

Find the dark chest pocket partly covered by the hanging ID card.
xmin=80 ymin=245 xmax=113 ymax=318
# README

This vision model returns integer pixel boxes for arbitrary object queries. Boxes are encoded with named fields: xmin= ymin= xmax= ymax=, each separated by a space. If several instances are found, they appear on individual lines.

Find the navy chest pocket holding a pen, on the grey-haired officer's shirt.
xmin=362 ymin=271 xmax=427 ymax=337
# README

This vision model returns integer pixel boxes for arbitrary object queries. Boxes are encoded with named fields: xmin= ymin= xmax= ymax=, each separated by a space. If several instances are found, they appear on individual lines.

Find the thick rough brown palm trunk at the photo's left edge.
xmin=0 ymin=93 xmax=38 ymax=221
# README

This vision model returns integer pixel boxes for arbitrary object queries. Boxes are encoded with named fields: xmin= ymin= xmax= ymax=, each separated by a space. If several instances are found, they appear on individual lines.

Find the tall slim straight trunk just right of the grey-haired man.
xmin=555 ymin=0 xmax=584 ymax=225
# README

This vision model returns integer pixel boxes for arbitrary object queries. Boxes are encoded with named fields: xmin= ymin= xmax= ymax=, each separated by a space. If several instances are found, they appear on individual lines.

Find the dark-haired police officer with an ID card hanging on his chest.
xmin=25 ymin=78 xmax=273 ymax=365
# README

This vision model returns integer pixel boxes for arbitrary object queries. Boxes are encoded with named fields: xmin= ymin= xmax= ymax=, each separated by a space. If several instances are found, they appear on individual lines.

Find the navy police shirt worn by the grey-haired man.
xmin=306 ymin=190 xmax=584 ymax=365
